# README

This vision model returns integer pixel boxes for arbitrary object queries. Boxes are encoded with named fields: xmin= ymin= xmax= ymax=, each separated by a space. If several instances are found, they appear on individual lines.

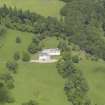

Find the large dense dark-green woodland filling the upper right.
xmin=60 ymin=0 xmax=105 ymax=60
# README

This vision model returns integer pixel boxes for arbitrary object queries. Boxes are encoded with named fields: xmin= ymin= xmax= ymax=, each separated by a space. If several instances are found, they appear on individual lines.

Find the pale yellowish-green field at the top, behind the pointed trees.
xmin=0 ymin=0 xmax=64 ymax=17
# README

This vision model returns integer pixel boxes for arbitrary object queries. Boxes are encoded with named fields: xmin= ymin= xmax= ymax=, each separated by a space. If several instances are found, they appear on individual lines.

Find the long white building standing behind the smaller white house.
xmin=42 ymin=48 xmax=61 ymax=56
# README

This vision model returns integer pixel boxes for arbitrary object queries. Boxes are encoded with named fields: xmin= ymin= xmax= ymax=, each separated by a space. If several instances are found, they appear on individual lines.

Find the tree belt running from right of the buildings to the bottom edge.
xmin=57 ymin=47 xmax=91 ymax=105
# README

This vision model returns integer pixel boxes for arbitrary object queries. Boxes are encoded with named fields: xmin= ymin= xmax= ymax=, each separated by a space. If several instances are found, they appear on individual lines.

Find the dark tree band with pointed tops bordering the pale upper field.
xmin=0 ymin=5 xmax=63 ymax=35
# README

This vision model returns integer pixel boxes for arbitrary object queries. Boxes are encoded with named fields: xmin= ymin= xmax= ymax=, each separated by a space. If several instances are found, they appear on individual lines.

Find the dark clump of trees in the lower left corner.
xmin=0 ymin=73 xmax=14 ymax=105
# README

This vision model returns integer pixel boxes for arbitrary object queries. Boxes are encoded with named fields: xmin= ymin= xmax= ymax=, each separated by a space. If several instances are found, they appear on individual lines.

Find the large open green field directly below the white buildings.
xmin=10 ymin=64 xmax=68 ymax=105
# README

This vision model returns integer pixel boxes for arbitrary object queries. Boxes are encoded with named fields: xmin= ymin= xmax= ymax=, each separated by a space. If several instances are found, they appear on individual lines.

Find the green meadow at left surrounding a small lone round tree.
xmin=0 ymin=30 xmax=32 ymax=61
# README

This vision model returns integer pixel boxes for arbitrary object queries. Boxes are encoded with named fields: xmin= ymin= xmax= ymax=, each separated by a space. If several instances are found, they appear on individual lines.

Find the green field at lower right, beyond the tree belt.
xmin=78 ymin=60 xmax=105 ymax=105
